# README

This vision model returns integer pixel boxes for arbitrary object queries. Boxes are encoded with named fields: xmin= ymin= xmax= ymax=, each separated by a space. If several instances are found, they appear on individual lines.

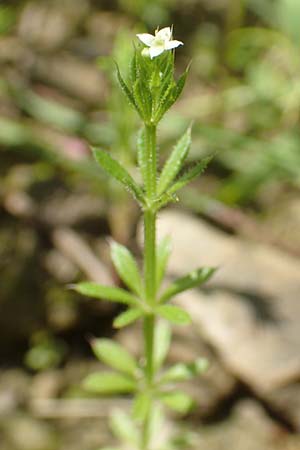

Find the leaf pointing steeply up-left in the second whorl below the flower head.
xmin=111 ymin=242 xmax=143 ymax=297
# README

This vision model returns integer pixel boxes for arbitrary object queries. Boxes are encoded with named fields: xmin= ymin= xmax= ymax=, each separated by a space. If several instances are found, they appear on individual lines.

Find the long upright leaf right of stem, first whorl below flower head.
xmin=157 ymin=127 xmax=191 ymax=195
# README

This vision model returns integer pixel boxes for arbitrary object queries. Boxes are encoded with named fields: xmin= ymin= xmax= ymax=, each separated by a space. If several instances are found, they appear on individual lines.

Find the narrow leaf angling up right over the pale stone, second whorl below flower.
xmin=159 ymin=267 xmax=216 ymax=303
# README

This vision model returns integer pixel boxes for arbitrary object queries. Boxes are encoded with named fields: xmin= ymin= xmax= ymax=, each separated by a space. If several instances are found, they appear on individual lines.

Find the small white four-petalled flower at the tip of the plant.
xmin=137 ymin=27 xmax=183 ymax=59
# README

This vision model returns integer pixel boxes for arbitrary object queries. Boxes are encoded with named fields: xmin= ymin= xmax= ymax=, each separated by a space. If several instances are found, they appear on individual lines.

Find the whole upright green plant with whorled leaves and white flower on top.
xmin=74 ymin=28 xmax=215 ymax=450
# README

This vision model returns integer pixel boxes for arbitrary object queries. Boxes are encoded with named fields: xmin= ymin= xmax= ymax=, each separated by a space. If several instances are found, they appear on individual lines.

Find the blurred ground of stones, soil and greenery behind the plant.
xmin=0 ymin=0 xmax=300 ymax=450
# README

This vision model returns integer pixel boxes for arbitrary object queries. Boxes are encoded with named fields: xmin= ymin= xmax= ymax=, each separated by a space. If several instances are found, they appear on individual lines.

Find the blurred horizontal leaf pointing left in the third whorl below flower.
xmin=83 ymin=372 xmax=136 ymax=394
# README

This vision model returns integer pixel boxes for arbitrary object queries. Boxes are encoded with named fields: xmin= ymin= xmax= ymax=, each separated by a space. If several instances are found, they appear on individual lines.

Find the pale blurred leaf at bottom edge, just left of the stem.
xmin=110 ymin=410 xmax=139 ymax=446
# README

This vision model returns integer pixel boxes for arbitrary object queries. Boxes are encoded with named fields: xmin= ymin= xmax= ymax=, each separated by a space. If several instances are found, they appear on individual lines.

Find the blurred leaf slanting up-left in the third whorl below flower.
xmin=91 ymin=338 xmax=137 ymax=376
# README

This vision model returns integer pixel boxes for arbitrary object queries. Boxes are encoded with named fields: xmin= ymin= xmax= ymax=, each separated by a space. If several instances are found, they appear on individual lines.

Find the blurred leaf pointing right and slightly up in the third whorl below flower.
xmin=161 ymin=358 xmax=208 ymax=383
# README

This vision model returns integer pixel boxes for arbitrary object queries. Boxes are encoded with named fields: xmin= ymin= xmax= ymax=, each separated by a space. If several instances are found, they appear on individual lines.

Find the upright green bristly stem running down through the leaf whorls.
xmin=141 ymin=125 xmax=157 ymax=450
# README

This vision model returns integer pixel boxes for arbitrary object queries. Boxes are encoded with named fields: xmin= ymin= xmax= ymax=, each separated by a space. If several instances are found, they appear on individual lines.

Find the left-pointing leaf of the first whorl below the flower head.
xmin=92 ymin=148 xmax=144 ymax=204
